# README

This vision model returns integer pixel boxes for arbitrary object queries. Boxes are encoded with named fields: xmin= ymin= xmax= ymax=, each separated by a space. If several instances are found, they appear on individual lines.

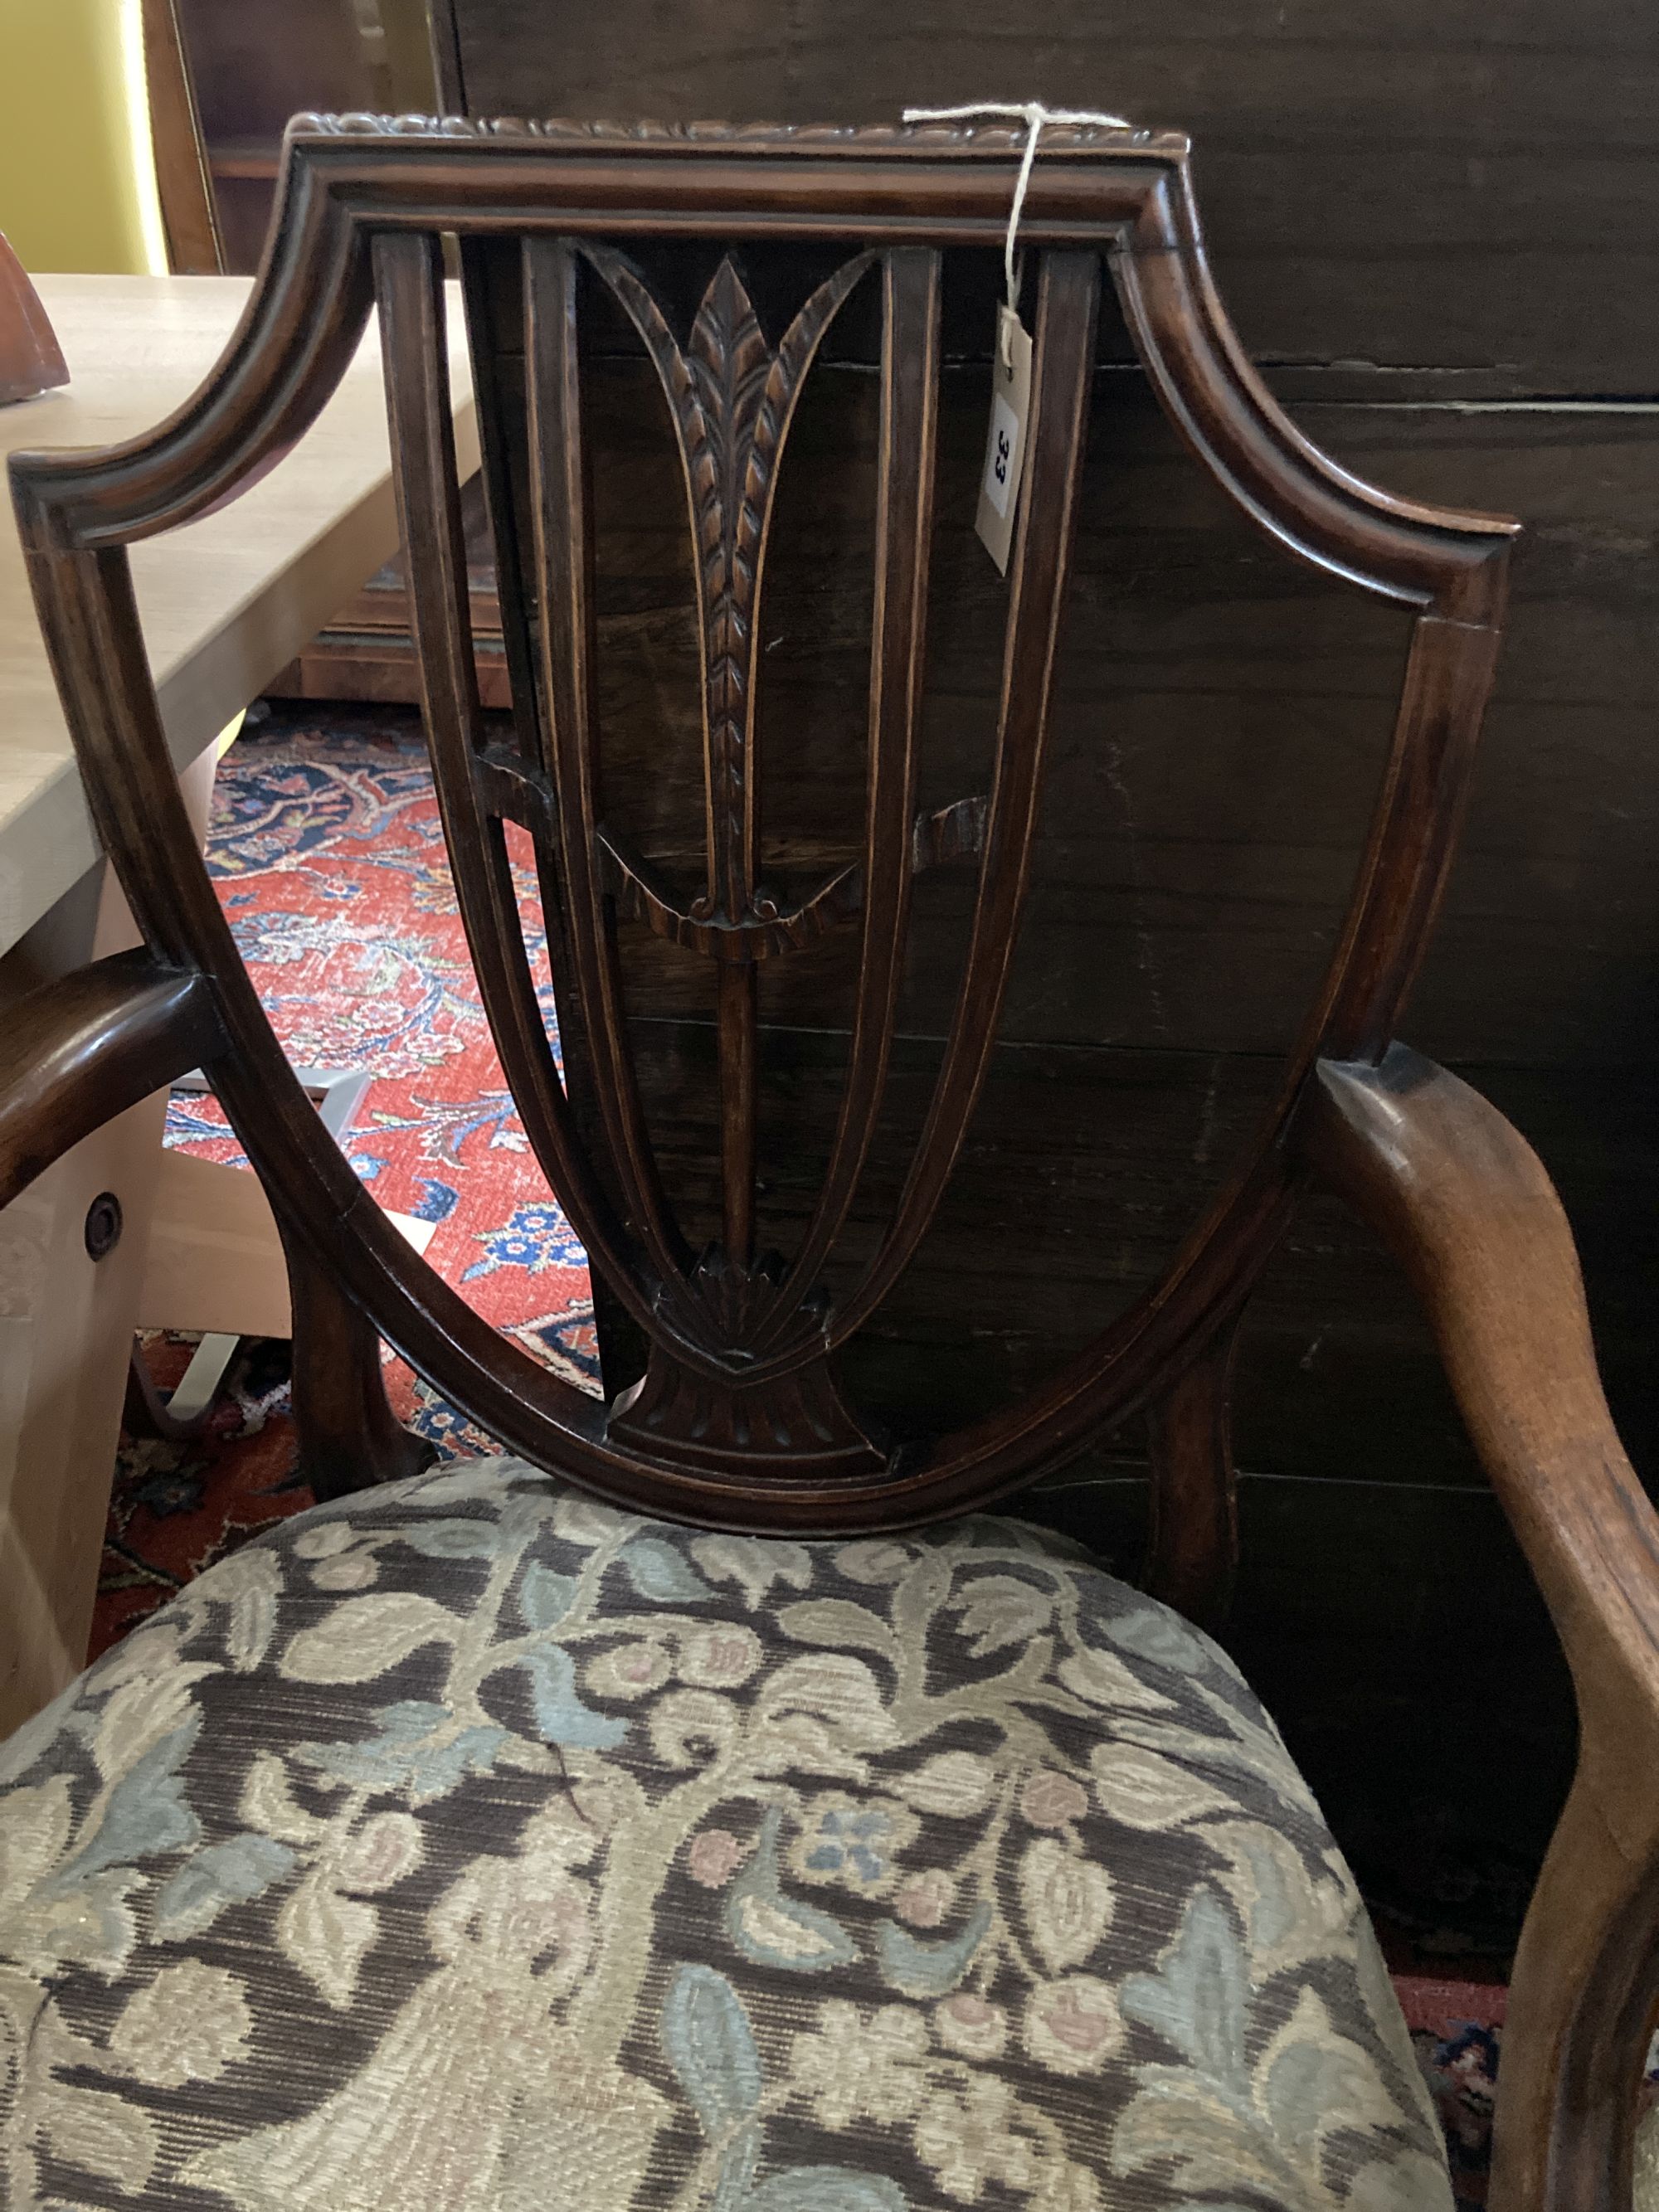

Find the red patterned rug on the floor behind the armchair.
xmin=90 ymin=707 xmax=1601 ymax=2212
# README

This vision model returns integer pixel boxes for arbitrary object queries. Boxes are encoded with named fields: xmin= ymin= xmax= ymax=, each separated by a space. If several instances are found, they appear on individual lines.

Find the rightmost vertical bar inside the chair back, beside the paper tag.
xmin=832 ymin=252 xmax=1099 ymax=1343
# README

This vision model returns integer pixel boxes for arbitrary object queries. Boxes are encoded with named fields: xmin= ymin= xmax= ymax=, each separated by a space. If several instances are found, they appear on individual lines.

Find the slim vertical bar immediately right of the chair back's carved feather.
xmin=757 ymin=248 xmax=940 ymax=1349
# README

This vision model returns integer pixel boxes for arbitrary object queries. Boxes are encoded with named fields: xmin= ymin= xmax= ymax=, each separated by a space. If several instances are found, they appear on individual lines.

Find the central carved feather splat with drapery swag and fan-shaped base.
xmin=584 ymin=246 xmax=911 ymax=1478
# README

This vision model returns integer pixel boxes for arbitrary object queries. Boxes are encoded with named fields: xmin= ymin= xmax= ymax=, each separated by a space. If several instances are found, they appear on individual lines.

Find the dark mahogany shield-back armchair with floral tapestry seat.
xmin=0 ymin=117 xmax=1659 ymax=2212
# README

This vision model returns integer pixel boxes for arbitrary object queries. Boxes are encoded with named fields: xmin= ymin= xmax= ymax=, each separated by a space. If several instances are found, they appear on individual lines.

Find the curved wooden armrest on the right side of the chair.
xmin=1301 ymin=1044 xmax=1659 ymax=2212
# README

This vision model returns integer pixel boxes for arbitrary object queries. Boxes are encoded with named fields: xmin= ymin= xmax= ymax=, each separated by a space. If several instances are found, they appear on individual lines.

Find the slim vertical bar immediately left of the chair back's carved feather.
xmin=524 ymin=236 xmax=686 ymax=1283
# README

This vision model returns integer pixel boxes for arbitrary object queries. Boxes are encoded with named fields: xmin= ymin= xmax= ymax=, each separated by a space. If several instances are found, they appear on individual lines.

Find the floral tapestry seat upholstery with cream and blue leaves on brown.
xmin=0 ymin=1460 xmax=1451 ymax=2212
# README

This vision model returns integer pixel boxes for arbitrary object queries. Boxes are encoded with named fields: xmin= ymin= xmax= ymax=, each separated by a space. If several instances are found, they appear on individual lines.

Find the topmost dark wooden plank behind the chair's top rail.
xmin=454 ymin=0 xmax=1659 ymax=396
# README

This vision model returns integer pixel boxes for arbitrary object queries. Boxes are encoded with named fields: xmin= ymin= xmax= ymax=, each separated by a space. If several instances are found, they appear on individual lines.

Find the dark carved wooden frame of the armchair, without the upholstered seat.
xmin=0 ymin=117 xmax=1659 ymax=2212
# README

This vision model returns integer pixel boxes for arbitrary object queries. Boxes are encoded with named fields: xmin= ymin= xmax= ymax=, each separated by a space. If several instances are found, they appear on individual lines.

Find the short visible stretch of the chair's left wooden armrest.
xmin=0 ymin=951 xmax=226 ymax=1206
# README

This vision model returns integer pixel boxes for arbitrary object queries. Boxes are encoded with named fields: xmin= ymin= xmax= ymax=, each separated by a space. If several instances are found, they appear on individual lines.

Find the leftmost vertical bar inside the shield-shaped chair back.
xmin=374 ymin=232 xmax=650 ymax=1316
